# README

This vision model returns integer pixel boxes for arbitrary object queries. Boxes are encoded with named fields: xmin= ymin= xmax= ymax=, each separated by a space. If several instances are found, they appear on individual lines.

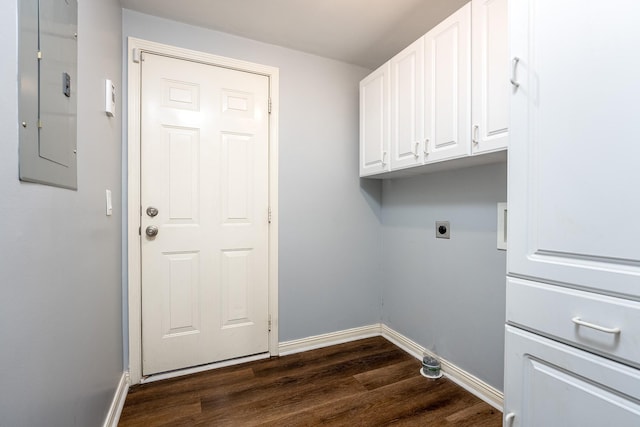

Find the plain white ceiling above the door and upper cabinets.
xmin=120 ymin=0 xmax=469 ymax=69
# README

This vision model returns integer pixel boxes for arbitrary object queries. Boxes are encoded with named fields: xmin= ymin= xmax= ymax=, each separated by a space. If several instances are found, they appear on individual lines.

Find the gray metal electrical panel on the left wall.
xmin=18 ymin=0 xmax=78 ymax=189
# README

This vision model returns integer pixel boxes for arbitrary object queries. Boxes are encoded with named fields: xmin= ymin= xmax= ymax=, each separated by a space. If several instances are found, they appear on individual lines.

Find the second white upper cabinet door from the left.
xmin=390 ymin=38 xmax=424 ymax=170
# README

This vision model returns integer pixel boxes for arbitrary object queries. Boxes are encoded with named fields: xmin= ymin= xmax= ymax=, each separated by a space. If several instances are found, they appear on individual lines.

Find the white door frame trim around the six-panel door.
xmin=127 ymin=37 xmax=280 ymax=384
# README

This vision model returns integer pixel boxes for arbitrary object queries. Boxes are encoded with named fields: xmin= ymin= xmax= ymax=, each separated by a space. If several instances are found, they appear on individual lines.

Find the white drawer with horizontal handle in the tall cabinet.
xmin=507 ymin=277 xmax=640 ymax=367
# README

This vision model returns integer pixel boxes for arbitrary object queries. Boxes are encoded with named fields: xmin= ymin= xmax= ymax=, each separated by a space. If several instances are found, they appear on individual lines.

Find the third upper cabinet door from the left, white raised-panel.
xmin=424 ymin=4 xmax=471 ymax=163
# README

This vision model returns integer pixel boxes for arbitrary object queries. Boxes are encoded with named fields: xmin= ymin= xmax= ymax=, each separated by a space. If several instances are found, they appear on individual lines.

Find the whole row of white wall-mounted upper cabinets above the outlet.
xmin=360 ymin=0 xmax=509 ymax=178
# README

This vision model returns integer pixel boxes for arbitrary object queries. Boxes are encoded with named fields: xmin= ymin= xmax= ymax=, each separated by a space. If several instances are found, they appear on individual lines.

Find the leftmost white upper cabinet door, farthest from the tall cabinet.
xmin=360 ymin=62 xmax=389 ymax=176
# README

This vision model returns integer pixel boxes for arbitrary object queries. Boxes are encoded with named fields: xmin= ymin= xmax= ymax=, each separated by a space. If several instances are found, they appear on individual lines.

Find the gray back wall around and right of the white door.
xmin=123 ymin=10 xmax=381 ymax=354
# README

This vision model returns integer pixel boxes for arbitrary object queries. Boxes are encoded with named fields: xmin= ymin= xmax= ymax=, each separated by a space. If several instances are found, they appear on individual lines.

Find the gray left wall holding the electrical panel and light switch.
xmin=0 ymin=0 xmax=123 ymax=427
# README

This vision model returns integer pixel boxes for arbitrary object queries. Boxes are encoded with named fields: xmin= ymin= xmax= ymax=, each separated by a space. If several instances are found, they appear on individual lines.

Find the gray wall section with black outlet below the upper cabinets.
xmin=382 ymin=163 xmax=507 ymax=390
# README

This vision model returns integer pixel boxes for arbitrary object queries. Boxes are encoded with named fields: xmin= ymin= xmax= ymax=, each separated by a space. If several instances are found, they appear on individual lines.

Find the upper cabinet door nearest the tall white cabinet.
xmin=471 ymin=0 xmax=509 ymax=154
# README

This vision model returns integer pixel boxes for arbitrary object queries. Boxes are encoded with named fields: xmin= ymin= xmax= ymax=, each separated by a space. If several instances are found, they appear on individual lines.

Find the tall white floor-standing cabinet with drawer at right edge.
xmin=504 ymin=0 xmax=640 ymax=427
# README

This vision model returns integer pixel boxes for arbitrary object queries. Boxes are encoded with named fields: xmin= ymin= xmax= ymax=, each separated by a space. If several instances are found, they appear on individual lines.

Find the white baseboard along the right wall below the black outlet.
xmin=380 ymin=325 xmax=504 ymax=412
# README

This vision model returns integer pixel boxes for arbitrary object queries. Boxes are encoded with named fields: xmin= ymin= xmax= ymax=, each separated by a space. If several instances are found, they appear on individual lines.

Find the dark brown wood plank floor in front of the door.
xmin=119 ymin=337 xmax=502 ymax=427
